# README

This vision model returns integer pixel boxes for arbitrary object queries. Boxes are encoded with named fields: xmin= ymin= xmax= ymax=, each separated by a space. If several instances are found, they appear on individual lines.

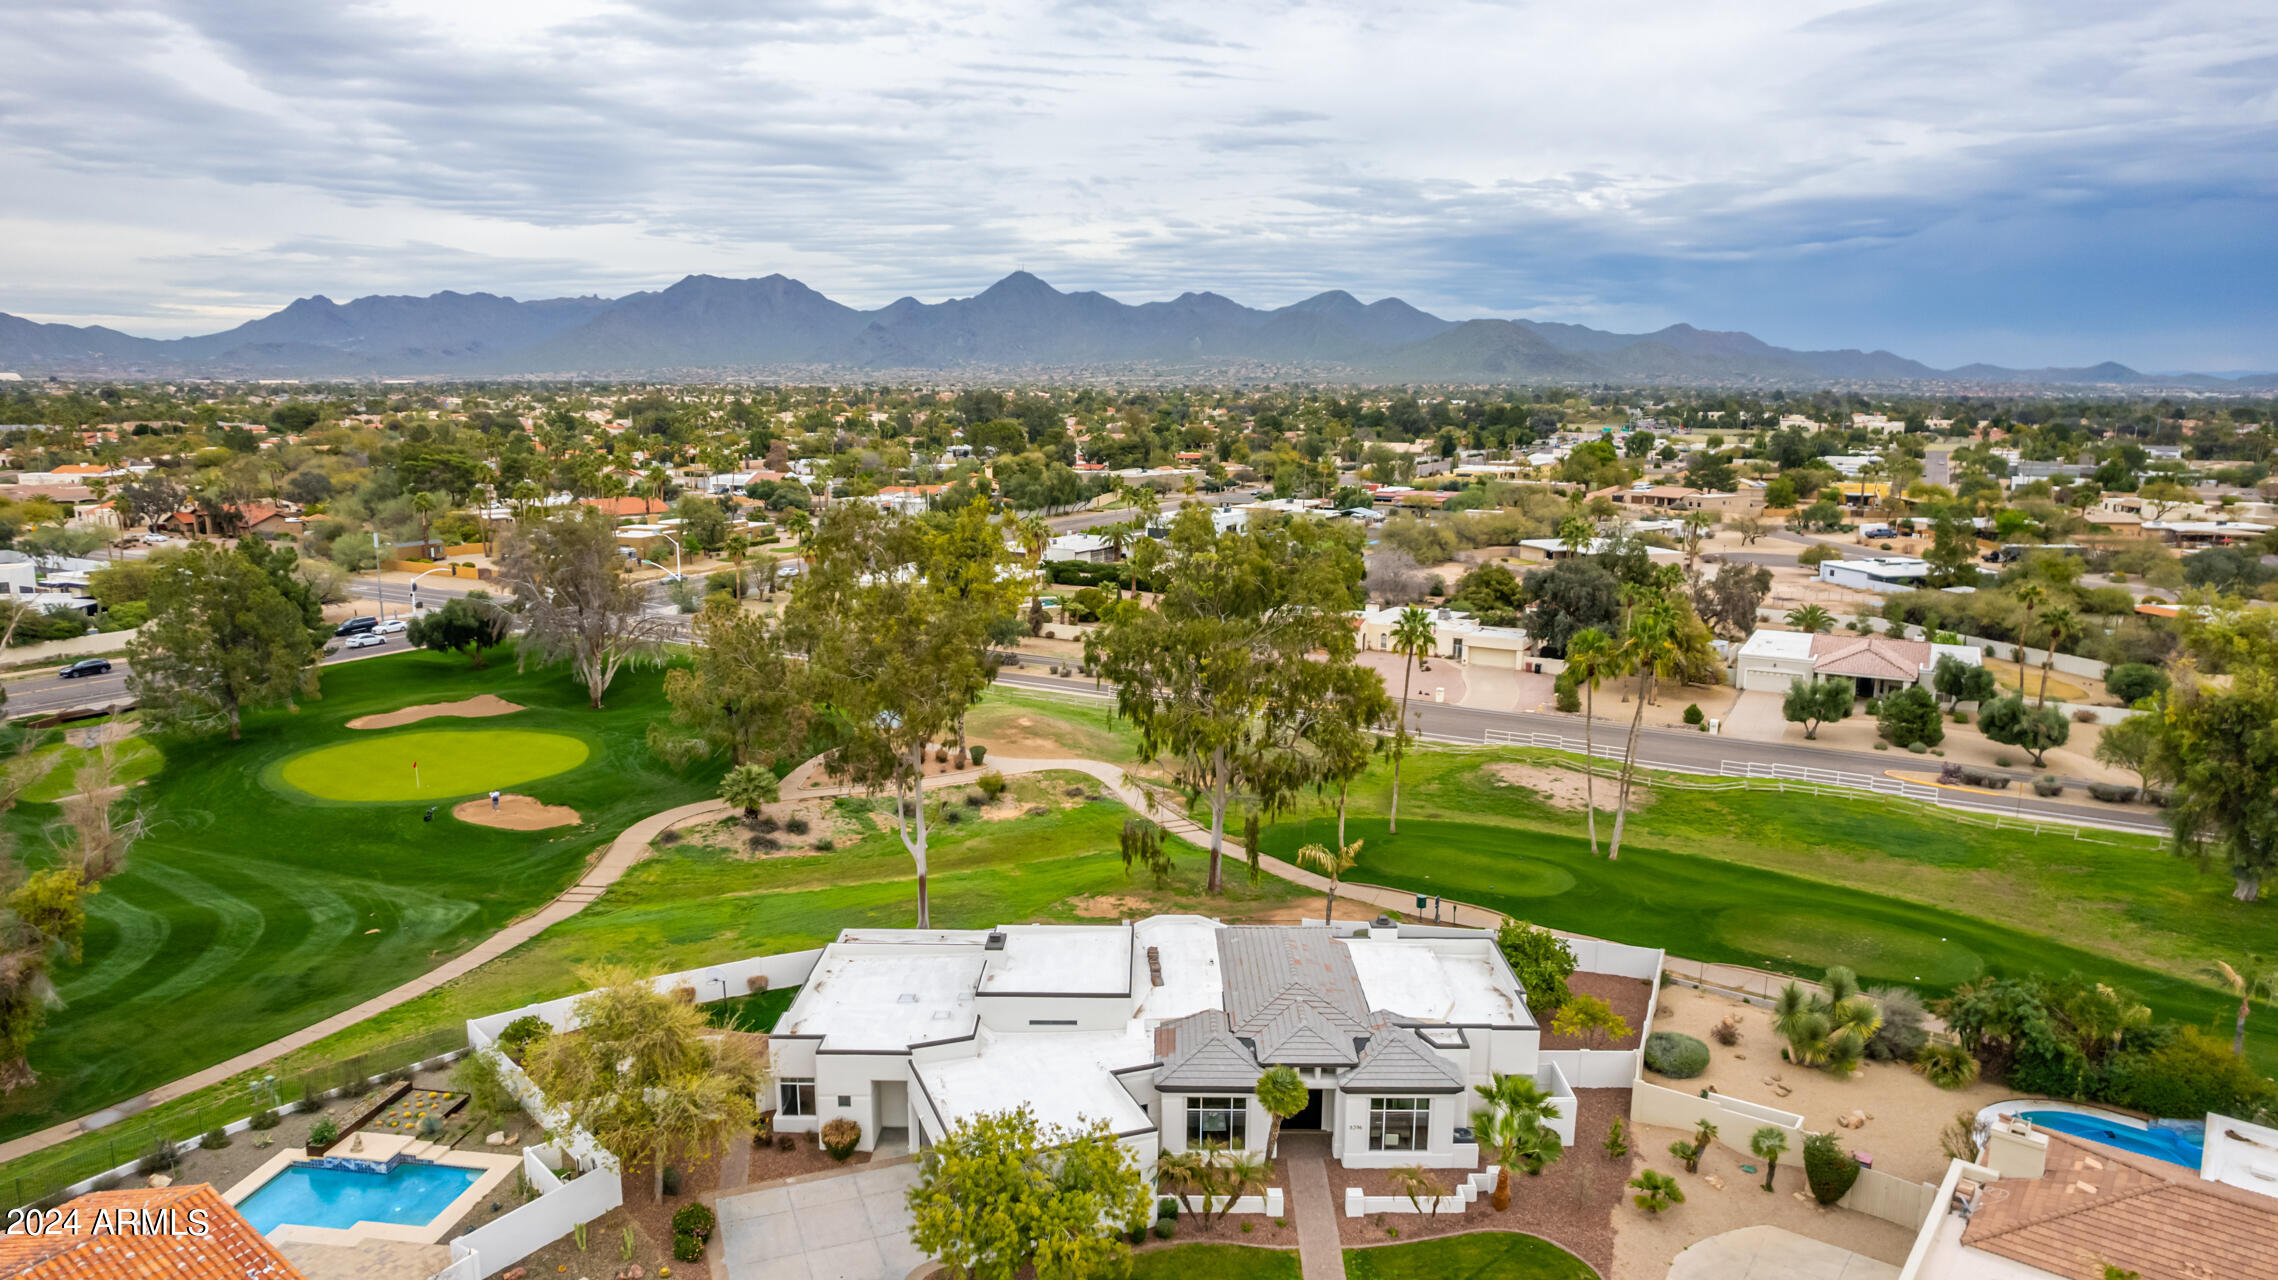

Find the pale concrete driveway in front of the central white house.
xmin=720 ymin=1164 xmax=925 ymax=1280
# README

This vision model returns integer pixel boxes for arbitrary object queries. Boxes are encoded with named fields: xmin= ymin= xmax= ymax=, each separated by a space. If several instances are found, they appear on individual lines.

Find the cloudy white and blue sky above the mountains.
xmin=0 ymin=0 xmax=2278 ymax=369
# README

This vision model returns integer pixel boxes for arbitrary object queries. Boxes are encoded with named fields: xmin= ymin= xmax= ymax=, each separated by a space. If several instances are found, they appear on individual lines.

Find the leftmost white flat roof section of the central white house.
xmin=777 ymin=932 xmax=986 ymax=1052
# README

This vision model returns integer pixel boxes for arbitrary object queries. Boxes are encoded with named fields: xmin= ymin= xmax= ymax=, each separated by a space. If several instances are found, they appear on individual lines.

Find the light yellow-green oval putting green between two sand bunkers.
xmin=278 ymin=729 xmax=590 ymax=804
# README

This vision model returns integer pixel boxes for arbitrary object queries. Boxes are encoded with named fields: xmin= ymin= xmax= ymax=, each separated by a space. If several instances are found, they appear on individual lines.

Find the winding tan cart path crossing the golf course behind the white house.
xmin=0 ymin=756 xmax=1788 ymax=1164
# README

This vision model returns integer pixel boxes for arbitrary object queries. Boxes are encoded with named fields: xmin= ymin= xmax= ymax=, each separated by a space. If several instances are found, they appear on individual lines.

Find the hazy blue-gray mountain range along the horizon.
xmin=0 ymin=271 xmax=2278 ymax=392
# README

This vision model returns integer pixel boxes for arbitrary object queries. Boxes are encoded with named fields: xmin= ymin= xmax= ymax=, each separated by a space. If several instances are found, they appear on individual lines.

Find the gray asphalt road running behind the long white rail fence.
xmin=998 ymin=670 xmax=2166 ymax=836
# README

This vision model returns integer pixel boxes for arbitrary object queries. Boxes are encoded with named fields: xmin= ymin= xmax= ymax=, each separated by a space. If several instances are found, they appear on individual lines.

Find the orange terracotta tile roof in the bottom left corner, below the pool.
xmin=0 ymin=1182 xmax=305 ymax=1280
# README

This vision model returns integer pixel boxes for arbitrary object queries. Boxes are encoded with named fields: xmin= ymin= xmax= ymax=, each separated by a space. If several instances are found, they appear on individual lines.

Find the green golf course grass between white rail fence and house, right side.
xmin=1264 ymin=752 xmax=2278 ymax=1064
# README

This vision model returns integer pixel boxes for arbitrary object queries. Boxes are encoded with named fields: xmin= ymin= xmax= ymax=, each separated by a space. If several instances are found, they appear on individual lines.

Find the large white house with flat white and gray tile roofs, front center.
xmin=768 ymin=916 xmax=1574 ymax=1168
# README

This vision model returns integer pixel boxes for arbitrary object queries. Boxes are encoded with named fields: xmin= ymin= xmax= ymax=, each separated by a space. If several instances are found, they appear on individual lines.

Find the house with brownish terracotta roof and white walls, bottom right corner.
xmin=1909 ymin=1116 xmax=2278 ymax=1280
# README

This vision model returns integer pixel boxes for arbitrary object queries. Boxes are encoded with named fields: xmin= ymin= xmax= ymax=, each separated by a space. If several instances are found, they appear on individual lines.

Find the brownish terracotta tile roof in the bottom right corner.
xmin=1961 ymin=1130 xmax=2278 ymax=1280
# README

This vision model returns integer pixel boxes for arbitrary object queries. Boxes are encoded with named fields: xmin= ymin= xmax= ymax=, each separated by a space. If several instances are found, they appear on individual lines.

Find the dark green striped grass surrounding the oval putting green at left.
xmin=0 ymin=654 xmax=724 ymax=1137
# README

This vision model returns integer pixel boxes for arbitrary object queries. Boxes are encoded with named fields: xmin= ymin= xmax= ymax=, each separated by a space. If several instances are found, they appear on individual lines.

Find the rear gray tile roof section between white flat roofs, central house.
xmin=1219 ymin=925 xmax=1369 ymax=1066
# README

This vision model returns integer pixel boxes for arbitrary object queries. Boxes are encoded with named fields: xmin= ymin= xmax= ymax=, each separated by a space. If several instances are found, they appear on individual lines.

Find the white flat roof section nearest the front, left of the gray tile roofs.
xmin=916 ymin=1025 xmax=1155 ymax=1134
